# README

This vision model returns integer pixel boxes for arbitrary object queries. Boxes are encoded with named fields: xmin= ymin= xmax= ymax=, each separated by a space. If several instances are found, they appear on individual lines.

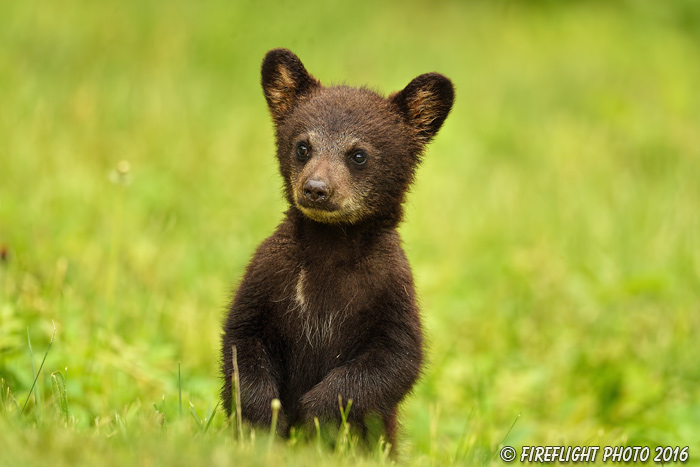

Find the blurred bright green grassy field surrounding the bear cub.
xmin=0 ymin=0 xmax=700 ymax=466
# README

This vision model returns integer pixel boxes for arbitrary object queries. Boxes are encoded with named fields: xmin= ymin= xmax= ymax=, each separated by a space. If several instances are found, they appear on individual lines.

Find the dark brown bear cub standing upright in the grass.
xmin=222 ymin=49 xmax=454 ymax=452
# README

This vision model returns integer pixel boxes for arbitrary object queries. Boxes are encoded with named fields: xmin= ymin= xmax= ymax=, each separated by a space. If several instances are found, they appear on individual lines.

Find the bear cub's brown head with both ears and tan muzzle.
xmin=262 ymin=49 xmax=454 ymax=224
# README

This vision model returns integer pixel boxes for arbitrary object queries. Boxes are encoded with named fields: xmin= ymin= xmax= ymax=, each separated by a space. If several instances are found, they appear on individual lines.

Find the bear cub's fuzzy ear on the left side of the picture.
xmin=262 ymin=49 xmax=321 ymax=125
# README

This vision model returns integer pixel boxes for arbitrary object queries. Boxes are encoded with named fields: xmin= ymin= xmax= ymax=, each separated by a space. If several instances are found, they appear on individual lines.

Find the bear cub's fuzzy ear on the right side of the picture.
xmin=389 ymin=73 xmax=455 ymax=144
